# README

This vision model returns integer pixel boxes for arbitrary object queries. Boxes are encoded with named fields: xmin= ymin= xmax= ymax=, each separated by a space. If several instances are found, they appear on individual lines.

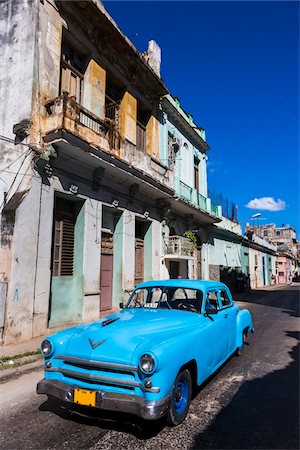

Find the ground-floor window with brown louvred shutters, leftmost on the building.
xmin=52 ymin=198 xmax=75 ymax=277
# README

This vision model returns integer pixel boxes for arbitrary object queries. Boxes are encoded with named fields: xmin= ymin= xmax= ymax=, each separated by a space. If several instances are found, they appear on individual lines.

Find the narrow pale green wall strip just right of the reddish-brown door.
xmin=112 ymin=215 xmax=124 ymax=306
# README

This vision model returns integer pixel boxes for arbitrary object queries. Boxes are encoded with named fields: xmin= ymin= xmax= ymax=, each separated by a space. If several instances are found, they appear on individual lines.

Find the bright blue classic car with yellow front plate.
xmin=37 ymin=279 xmax=253 ymax=425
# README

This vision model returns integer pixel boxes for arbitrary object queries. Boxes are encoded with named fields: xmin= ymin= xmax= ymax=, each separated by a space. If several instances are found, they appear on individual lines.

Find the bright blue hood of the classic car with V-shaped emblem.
xmin=67 ymin=308 xmax=202 ymax=364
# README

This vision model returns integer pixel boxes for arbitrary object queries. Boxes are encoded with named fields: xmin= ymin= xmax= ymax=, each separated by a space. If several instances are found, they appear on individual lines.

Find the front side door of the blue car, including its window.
xmin=204 ymin=289 xmax=228 ymax=368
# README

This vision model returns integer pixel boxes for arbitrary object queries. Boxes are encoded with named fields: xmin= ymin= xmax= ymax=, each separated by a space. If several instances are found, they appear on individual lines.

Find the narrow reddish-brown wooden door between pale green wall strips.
xmin=100 ymin=233 xmax=113 ymax=311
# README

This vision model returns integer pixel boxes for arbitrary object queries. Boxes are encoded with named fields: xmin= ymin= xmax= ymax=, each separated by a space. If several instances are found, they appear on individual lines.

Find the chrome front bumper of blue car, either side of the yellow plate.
xmin=36 ymin=379 xmax=170 ymax=420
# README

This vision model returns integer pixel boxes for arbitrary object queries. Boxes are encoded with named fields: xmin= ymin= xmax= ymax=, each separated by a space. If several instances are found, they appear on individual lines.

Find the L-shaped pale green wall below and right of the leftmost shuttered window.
xmin=49 ymin=203 xmax=84 ymax=327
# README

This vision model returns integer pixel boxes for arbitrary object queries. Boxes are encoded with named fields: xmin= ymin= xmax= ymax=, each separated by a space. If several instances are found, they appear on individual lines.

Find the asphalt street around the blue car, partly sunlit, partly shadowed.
xmin=0 ymin=286 xmax=299 ymax=450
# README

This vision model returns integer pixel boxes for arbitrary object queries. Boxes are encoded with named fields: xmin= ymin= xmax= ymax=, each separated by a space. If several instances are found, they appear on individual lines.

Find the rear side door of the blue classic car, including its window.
xmin=218 ymin=288 xmax=238 ymax=354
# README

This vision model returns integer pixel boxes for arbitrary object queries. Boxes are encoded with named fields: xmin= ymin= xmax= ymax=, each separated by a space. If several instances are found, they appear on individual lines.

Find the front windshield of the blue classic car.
xmin=126 ymin=286 xmax=203 ymax=313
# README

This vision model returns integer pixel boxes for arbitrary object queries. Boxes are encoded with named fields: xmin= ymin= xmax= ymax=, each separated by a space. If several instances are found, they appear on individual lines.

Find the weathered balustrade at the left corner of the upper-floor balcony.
xmin=42 ymin=93 xmax=119 ymax=151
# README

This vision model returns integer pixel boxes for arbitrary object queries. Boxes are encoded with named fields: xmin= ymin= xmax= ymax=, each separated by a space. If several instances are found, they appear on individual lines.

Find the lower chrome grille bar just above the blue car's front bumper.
xmin=45 ymin=367 xmax=160 ymax=394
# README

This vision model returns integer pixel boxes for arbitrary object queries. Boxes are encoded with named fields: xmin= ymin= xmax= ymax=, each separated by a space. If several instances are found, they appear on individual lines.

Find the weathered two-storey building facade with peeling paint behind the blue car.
xmin=0 ymin=0 xmax=220 ymax=343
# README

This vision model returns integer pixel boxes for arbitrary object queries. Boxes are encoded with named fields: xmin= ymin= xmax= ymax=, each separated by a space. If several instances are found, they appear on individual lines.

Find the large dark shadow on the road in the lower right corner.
xmin=192 ymin=332 xmax=299 ymax=449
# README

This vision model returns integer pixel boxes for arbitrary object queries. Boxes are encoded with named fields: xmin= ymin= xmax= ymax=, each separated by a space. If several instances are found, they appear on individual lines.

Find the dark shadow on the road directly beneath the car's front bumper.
xmin=39 ymin=398 xmax=166 ymax=439
